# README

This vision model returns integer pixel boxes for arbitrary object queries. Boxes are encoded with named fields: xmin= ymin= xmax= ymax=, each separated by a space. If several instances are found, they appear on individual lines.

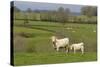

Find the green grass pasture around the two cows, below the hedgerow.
xmin=14 ymin=20 xmax=97 ymax=65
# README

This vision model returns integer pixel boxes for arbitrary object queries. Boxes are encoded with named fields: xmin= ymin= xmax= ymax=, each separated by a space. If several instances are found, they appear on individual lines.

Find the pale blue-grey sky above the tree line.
xmin=14 ymin=1 xmax=86 ymax=12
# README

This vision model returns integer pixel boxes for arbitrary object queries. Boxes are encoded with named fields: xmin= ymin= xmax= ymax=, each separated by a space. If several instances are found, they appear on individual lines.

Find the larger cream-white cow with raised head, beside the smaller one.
xmin=51 ymin=36 xmax=69 ymax=52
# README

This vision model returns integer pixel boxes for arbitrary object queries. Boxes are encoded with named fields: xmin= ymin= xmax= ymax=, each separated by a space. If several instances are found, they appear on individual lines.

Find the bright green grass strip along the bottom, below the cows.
xmin=14 ymin=52 xmax=97 ymax=65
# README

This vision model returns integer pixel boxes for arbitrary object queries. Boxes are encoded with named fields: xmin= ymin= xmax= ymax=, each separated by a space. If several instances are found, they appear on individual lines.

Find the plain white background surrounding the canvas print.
xmin=0 ymin=0 xmax=100 ymax=67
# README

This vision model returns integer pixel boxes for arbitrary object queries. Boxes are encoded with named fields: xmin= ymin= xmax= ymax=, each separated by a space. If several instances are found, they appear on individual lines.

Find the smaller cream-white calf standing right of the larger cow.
xmin=70 ymin=42 xmax=84 ymax=54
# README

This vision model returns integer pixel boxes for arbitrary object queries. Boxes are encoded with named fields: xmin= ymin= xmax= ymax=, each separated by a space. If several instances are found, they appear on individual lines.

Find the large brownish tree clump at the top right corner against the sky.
xmin=81 ymin=6 xmax=97 ymax=17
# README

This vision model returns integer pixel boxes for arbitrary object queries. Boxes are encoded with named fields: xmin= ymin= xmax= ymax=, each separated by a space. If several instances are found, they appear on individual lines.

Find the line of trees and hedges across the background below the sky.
xmin=13 ymin=6 xmax=97 ymax=24
